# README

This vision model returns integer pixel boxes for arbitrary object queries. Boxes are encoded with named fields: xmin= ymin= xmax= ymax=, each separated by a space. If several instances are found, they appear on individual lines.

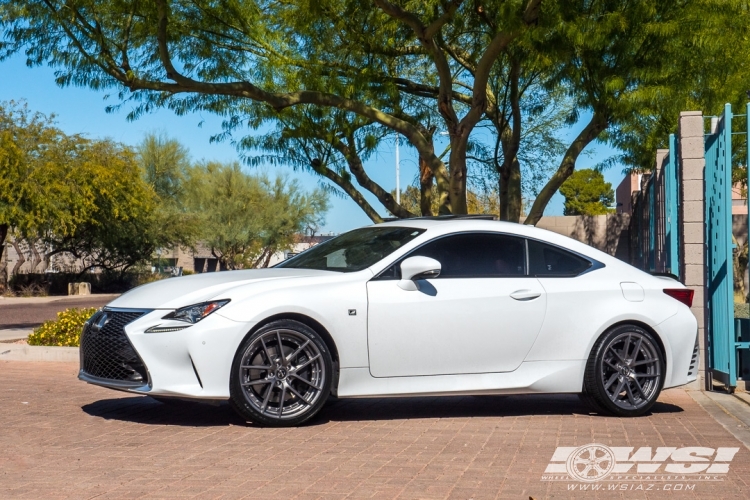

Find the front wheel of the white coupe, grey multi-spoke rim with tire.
xmin=229 ymin=320 xmax=333 ymax=427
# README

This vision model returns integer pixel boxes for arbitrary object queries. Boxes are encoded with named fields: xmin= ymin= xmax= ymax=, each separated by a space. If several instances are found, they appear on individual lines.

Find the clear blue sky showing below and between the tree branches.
xmin=0 ymin=55 xmax=623 ymax=233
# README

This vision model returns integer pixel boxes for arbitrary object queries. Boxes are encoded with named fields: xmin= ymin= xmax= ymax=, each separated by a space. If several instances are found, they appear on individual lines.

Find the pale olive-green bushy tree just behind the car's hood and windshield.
xmin=185 ymin=162 xmax=328 ymax=269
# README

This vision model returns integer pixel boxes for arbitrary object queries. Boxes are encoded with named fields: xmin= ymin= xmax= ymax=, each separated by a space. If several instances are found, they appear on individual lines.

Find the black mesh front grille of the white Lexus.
xmin=81 ymin=309 xmax=148 ymax=385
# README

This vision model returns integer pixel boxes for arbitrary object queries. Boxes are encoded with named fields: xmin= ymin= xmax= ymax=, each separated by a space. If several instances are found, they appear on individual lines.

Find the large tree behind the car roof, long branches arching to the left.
xmin=0 ymin=0 xmax=540 ymax=219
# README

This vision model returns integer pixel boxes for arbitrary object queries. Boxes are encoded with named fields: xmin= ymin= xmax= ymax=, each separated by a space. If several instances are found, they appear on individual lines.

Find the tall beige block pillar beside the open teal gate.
xmin=677 ymin=111 xmax=711 ymax=389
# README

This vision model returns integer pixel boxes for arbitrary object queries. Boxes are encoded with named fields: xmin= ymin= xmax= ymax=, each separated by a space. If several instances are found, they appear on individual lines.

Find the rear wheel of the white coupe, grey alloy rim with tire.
xmin=583 ymin=325 xmax=665 ymax=417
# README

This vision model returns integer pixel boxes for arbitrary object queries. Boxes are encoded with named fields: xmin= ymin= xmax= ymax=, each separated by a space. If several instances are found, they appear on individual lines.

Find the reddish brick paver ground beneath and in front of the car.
xmin=0 ymin=361 xmax=750 ymax=500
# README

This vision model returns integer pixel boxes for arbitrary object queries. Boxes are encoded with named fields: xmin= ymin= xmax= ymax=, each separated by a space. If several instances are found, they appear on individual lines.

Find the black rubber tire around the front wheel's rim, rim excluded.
xmin=229 ymin=320 xmax=333 ymax=427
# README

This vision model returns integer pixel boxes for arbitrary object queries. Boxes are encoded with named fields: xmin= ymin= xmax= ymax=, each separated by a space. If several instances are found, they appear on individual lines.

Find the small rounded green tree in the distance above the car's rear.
xmin=560 ymin=168 xmax=615 ymax=215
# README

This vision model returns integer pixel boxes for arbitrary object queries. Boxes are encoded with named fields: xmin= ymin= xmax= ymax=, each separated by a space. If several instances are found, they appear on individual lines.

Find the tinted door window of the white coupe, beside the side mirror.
xmin=409 ymin=233 xmax=526 ymax=279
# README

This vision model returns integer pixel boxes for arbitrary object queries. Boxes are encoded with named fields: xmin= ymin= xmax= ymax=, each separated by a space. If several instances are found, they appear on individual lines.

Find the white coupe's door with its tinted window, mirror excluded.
xmin=367 ymin=232 xmax=546 ymax=377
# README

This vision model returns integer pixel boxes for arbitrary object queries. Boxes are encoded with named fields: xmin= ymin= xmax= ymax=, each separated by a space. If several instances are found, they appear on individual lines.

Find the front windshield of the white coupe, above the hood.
xmin=276 ymin=226 xmax=424 ymax=273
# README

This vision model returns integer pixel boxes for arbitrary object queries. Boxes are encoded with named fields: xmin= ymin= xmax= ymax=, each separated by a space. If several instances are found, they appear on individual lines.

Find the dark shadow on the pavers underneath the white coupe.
xmin=81 ymin=394 xmax=683 ymax=427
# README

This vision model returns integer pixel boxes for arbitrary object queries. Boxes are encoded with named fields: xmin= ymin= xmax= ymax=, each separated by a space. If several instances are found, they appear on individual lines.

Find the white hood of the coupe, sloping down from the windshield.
xmin=107 ymin=268 xmax=338 ymax=309
